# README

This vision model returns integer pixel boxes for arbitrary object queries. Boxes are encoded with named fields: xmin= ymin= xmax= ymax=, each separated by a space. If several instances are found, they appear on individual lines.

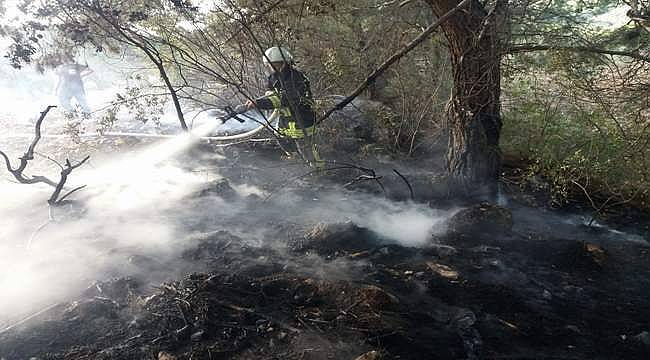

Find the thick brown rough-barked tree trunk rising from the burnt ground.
xmin=427 ymin=0 xmax=501 ymax=195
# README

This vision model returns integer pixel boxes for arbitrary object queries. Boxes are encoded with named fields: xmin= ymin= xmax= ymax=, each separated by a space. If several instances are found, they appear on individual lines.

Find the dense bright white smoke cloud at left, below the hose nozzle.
xmin=0 ymin=120 xmax=225 ymax=323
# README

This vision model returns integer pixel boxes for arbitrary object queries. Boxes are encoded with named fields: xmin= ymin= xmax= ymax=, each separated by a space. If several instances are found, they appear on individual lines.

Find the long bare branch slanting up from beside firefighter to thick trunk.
xmin=316 ymin=0 xmax=470 ymax=124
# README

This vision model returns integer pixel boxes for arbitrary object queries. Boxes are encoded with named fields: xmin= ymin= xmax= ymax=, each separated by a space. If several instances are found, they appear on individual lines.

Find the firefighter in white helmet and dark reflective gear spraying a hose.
xmin=246 ymin=46 xmax=323 ymax=167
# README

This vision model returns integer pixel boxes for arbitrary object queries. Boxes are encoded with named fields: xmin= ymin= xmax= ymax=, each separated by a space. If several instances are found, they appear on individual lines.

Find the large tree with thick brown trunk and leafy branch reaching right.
xmin=426 ymin=0 xmax=650 ymax=194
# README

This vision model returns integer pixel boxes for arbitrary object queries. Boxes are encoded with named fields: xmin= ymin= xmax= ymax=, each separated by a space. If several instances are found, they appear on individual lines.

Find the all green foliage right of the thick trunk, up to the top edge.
xmin=501 ymin=0 xmax=650 ymax=212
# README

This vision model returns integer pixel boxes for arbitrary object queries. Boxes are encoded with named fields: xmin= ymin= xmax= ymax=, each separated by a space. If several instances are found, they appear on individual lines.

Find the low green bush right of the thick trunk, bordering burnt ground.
xmin=501 ymin=67 xmax=650 ymax=211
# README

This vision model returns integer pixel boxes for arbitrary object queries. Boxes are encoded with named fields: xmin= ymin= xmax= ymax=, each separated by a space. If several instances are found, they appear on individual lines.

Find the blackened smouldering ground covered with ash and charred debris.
xmin=0 ymin=136 xmax=650 ymax=360
